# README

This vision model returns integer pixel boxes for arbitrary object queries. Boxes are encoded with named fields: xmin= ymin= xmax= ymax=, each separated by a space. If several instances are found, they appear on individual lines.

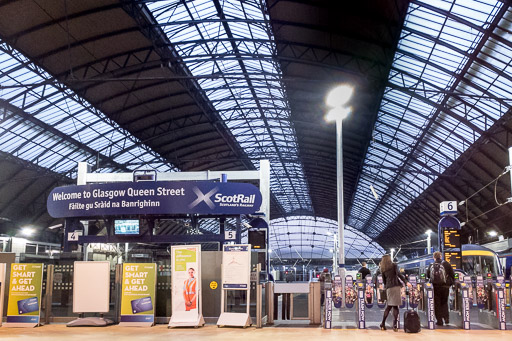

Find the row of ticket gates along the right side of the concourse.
xmin=322 ymin=275 xmax=511 ymax=330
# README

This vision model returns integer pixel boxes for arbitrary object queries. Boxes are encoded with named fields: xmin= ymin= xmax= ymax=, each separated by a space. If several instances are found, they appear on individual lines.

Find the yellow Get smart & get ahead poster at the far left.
xmin=7 ymin=263 xmax=43 ymax=327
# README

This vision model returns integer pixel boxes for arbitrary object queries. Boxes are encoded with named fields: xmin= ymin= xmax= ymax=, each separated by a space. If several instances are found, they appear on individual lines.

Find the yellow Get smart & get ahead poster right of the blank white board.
xmin=121 ymin=263 xmax=156 ymax=325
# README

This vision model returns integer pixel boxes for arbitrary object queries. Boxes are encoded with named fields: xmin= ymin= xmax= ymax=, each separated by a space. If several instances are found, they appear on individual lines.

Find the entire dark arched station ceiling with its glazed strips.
xmin=0 ymin=0 xmax=512 ymax=258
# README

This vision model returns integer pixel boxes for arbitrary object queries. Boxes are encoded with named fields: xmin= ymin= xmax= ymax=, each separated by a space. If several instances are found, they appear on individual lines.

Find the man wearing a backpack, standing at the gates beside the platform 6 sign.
xmin=427 ymin=251 xmax=455 ymax=326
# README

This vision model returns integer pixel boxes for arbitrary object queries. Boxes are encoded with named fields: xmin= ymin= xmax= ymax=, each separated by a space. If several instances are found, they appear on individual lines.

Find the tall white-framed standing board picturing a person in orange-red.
xmin=169 ymin=245 xmax=204 ymax=327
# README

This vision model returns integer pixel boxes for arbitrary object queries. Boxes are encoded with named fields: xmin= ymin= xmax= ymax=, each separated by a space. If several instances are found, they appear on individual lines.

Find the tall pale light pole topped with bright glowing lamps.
xmin=325 ymin=85 xmax=354 ymax=280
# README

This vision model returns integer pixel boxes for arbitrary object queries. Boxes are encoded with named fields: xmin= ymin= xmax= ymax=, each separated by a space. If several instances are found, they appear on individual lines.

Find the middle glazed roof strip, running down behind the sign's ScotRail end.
xmin=146 ymin=0 xmax=311 ymax=212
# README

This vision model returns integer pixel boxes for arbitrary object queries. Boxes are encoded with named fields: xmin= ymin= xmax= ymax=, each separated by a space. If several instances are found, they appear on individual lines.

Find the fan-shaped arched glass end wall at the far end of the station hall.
xmin=269 ymin=216 xmax=384 ymax=259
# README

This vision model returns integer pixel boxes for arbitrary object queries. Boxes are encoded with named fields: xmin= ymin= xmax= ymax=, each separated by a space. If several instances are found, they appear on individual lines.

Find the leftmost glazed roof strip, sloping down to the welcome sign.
xmin=0 ymin=40 xmax=175 ymax=177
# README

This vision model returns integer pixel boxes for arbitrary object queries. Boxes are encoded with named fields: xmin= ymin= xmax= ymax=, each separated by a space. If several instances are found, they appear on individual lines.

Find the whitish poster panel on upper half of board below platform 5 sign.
xmin=222 ymin=244 xmax=251 ymax=289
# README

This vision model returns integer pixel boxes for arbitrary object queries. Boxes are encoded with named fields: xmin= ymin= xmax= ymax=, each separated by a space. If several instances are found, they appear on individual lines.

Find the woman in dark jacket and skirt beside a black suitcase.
xmin=379 ymin=255 xmax=406 ymax=332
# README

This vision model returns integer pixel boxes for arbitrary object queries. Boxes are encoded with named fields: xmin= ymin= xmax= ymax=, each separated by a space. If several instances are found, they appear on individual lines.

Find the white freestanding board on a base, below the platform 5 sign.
xmin=217 ymin=244 xmax=252 ymax=328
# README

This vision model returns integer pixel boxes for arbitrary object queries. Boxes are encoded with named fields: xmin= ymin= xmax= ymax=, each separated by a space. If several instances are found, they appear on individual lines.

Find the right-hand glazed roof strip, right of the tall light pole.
xmin=348 ymin=0 xmax=512 ymax=237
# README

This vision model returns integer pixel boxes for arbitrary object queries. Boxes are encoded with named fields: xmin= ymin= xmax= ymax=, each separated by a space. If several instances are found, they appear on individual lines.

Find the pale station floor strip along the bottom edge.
xmin=0 ymin=324 xmax=512 ymax=341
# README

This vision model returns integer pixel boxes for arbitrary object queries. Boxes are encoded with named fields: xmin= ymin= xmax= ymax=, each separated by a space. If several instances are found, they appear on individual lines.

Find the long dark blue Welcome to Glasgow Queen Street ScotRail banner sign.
xmin=47 ymin=181 xmax=261 ymax=218
